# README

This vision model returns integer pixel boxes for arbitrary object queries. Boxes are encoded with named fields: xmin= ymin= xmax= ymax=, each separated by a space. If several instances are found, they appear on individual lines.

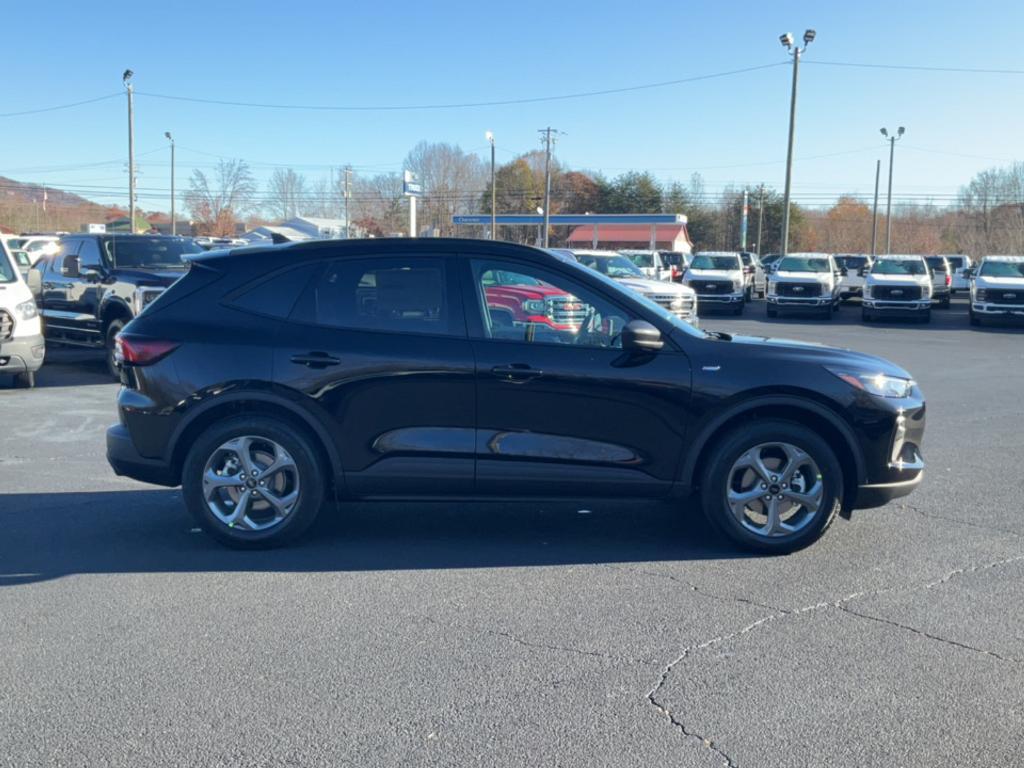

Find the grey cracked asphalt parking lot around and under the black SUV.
xmin=0 ymin=300 xmax=1024 ymax=768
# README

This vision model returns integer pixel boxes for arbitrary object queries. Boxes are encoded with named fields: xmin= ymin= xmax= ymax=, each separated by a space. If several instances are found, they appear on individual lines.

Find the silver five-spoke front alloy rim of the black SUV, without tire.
xmin=725 ymin=442 xmax=824 ymax=539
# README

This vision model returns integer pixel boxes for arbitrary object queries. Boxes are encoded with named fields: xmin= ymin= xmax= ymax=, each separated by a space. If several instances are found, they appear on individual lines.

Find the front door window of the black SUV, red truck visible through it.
xmin=473 ymin=261 xmax=633 ymax=349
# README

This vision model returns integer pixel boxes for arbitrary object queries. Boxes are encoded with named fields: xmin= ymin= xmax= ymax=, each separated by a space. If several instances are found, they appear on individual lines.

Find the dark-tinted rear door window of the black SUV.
xmin=302 ymin=256 xmax=461 ymax=335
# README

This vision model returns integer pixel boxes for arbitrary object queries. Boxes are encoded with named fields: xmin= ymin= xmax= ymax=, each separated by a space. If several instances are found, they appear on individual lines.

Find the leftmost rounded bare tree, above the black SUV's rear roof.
xmin=185 ymin=160 xmax=256 ymax=234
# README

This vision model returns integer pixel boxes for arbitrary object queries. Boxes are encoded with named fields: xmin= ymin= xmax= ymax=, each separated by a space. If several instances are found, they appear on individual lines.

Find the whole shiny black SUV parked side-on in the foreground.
xmin=106 ymin=240 xmax=925 ymax=552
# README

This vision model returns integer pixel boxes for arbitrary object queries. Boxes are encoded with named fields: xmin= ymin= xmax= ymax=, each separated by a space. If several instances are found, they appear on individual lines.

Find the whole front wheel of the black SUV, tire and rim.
xmin=700 ymin=421 xmax=843 ymax=554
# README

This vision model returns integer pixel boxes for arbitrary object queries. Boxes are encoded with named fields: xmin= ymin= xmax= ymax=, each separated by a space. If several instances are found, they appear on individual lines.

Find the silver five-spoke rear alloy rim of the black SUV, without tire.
xmin=203 ymin=435 xmax=300 ymax=531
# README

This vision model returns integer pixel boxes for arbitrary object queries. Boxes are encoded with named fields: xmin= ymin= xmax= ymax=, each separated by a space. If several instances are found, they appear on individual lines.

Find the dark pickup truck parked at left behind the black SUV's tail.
xmin=31 ymin=234 xmax=203 ymax=376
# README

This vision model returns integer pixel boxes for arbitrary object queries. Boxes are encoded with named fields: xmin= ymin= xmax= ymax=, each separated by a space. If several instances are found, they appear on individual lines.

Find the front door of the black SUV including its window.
xmin=467 ymin=260 xmax=690 ymax=497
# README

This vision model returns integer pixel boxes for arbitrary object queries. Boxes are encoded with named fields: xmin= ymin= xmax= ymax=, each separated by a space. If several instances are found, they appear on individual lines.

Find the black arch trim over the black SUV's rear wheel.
xmin=168 ymin=391 xmax=344 ymax=492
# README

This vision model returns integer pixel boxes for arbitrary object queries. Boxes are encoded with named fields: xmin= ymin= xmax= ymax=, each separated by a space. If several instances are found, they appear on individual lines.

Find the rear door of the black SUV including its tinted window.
xmin=274 ymin=254 xmax=475 ymax=497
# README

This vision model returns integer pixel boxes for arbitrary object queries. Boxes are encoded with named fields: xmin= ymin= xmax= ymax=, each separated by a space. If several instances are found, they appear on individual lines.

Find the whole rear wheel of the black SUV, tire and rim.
xmin=181 ymin=417 xmax=325 ymax=549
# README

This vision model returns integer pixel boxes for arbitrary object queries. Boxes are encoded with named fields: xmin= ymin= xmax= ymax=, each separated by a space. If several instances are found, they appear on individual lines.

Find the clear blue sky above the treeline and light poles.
xmin=0 ymin=0 xmax=1024 ymax=210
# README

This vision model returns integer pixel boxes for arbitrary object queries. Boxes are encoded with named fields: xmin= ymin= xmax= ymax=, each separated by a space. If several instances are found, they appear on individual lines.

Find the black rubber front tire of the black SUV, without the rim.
xmin=700 ymin=420 xmax=844 ymax=554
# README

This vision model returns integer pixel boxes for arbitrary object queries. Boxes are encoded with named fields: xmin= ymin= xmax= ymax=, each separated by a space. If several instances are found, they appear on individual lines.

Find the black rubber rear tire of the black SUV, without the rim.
xmin=181 ymin=416 xmax=328 ymax=549
